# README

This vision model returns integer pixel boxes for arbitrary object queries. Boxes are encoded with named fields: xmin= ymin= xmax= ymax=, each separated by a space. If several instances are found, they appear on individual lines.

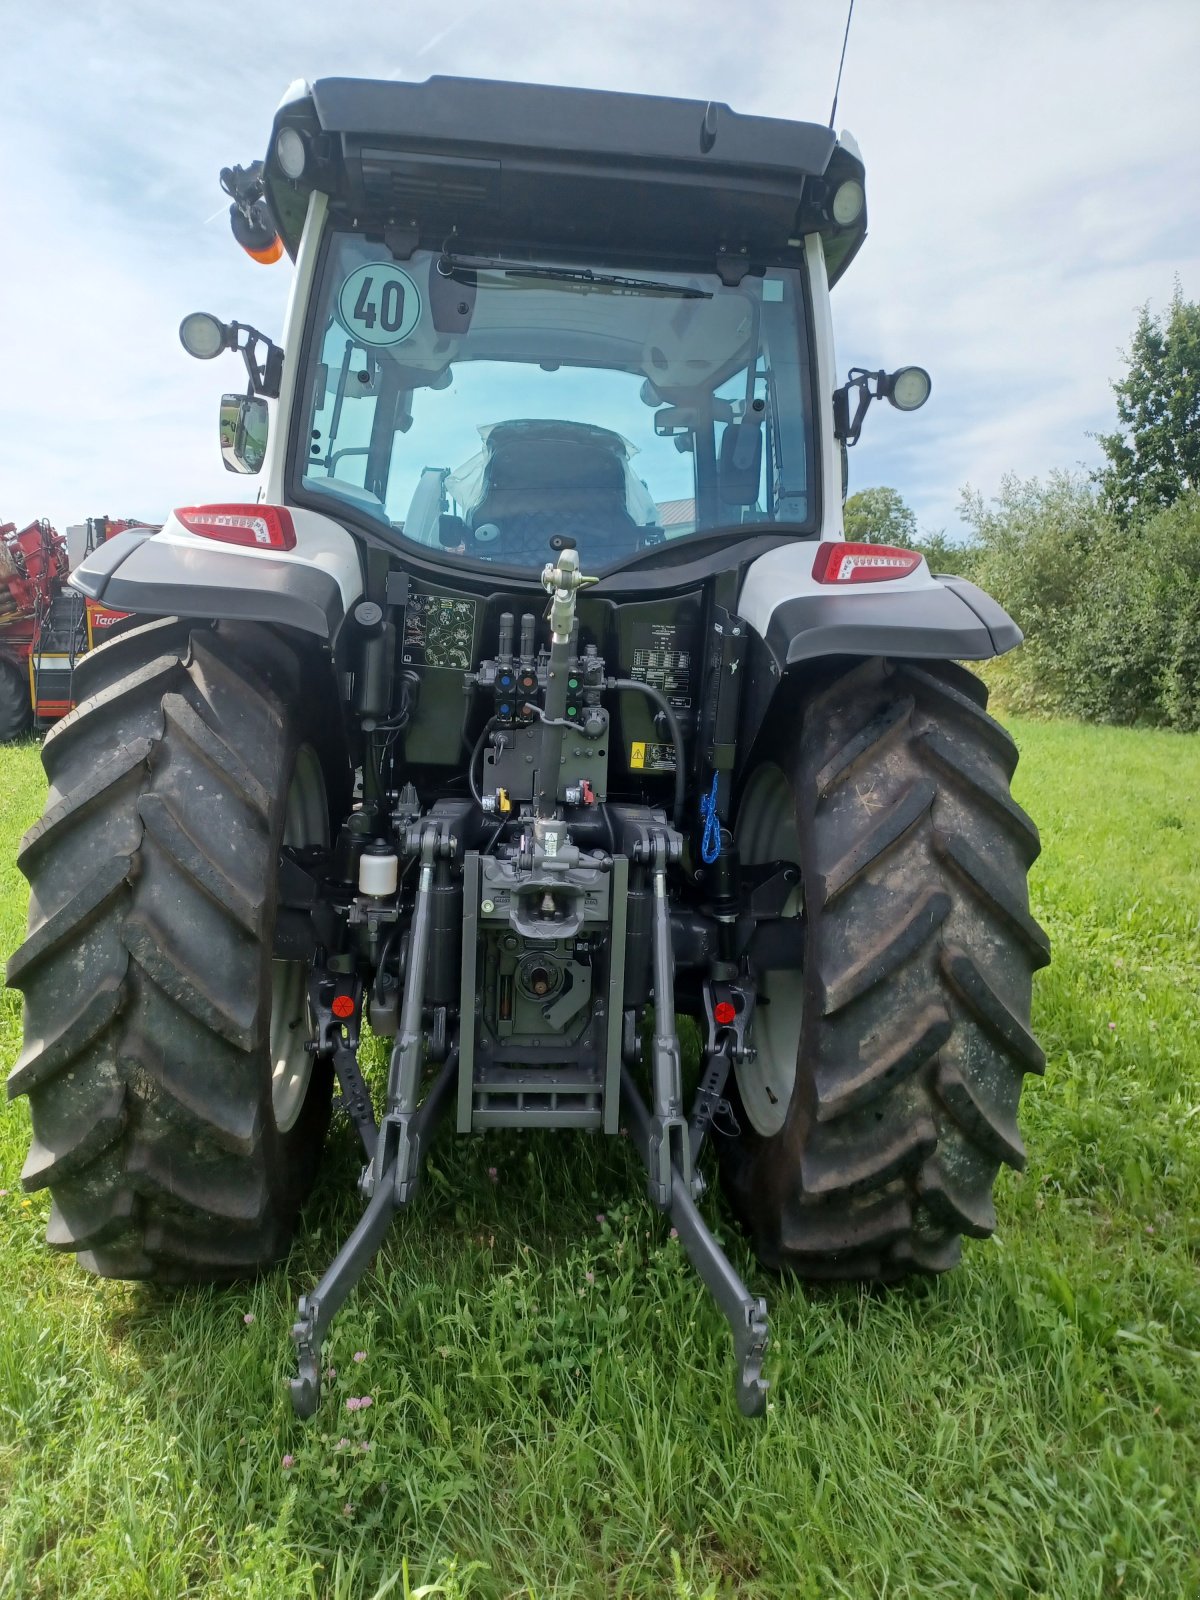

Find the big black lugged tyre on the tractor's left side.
xmin=8 ymin=619 xmax=331 ymax=1282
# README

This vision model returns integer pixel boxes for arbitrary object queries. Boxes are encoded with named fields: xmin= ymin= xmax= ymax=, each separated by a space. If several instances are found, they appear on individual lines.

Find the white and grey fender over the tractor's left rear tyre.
xmin=70 ymin=502 xmax=363 ymax=642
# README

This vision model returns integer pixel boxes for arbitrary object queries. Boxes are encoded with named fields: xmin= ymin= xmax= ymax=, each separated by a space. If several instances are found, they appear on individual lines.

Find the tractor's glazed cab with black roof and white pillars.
xmin=220 ymin=78 xmax=866 ymax=576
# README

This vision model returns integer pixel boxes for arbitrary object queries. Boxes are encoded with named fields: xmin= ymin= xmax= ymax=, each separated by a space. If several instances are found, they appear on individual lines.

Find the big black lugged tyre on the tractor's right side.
xmin=722 ymin=661 xmax=1050 ymax=1282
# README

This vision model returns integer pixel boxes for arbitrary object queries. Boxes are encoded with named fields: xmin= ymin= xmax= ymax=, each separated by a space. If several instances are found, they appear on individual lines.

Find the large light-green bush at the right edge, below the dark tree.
xmin=960 ymin=474 xmax=1200 ymax=731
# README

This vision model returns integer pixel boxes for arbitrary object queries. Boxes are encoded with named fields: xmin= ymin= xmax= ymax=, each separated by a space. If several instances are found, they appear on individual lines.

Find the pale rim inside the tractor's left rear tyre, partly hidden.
xmin=270 ymin=744 xmax=330 ymax=1133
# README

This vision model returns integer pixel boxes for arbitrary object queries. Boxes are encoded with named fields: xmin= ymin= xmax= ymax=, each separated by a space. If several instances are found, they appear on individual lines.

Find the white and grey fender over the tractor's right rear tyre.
xmin=738 ymin=542 xmax=1022 ymax=670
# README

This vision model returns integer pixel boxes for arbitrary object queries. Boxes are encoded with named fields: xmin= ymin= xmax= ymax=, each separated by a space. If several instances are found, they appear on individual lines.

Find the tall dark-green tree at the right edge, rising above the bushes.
xmin=1094 ymin=280 xmax=1200 ymax=526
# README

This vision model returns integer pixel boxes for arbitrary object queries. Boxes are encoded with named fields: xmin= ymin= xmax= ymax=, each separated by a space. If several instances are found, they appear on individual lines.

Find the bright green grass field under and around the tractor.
xmin=0 ymin=723 xmax=1200 ymax=1600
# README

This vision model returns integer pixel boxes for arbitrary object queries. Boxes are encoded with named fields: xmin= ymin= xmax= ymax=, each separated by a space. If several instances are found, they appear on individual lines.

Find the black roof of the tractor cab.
xmin=264 ymin=77 xmax=866 ymax=282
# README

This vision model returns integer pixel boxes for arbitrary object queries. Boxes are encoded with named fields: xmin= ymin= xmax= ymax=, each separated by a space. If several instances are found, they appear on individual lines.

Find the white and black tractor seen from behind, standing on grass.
xmin=8 ymin=77 xmax=1048 ymax=1416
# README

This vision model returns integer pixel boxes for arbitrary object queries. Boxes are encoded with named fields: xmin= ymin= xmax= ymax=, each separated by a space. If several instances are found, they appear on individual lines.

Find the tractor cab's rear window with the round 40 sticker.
xmin=299 ymin=234 xmax=814 ymax=571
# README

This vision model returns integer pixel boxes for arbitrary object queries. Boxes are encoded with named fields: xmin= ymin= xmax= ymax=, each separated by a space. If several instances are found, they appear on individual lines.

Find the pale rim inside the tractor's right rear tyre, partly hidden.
xmin=734 ymin=762 xmax=805 ymax=1138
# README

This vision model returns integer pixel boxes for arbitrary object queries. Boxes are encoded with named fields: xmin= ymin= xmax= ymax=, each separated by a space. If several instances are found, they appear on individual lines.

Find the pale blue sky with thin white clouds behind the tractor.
xmin=0 ymin=0 xmax=1200 ymax=531
